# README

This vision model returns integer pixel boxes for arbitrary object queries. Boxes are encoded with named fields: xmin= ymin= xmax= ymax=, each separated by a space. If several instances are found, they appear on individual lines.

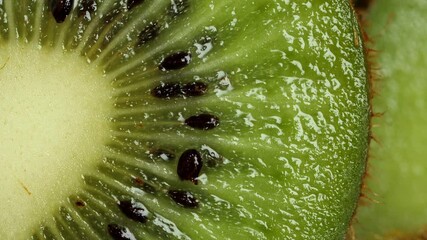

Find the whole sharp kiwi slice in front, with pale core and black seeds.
xmin=0 ymin=0 xmax=370 ymax=239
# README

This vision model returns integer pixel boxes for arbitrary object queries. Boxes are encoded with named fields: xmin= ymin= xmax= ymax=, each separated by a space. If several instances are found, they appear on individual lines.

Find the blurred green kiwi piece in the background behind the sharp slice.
xmin=356 ymin=0 xmax=427 ymax=237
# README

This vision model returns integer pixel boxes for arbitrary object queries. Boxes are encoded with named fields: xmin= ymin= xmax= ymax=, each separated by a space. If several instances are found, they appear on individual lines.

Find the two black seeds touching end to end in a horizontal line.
xmin=151 ymin=81 xmax=208 ymax=99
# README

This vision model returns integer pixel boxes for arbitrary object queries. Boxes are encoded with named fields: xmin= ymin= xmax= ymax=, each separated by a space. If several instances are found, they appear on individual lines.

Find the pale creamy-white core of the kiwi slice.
xmin=0 ymin=44 xmax=112 ymax=238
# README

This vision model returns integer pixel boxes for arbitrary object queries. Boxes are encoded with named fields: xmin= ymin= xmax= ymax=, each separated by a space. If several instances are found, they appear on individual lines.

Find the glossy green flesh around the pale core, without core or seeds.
xmin=0 ymin=0 xmax=370 ymax=239
